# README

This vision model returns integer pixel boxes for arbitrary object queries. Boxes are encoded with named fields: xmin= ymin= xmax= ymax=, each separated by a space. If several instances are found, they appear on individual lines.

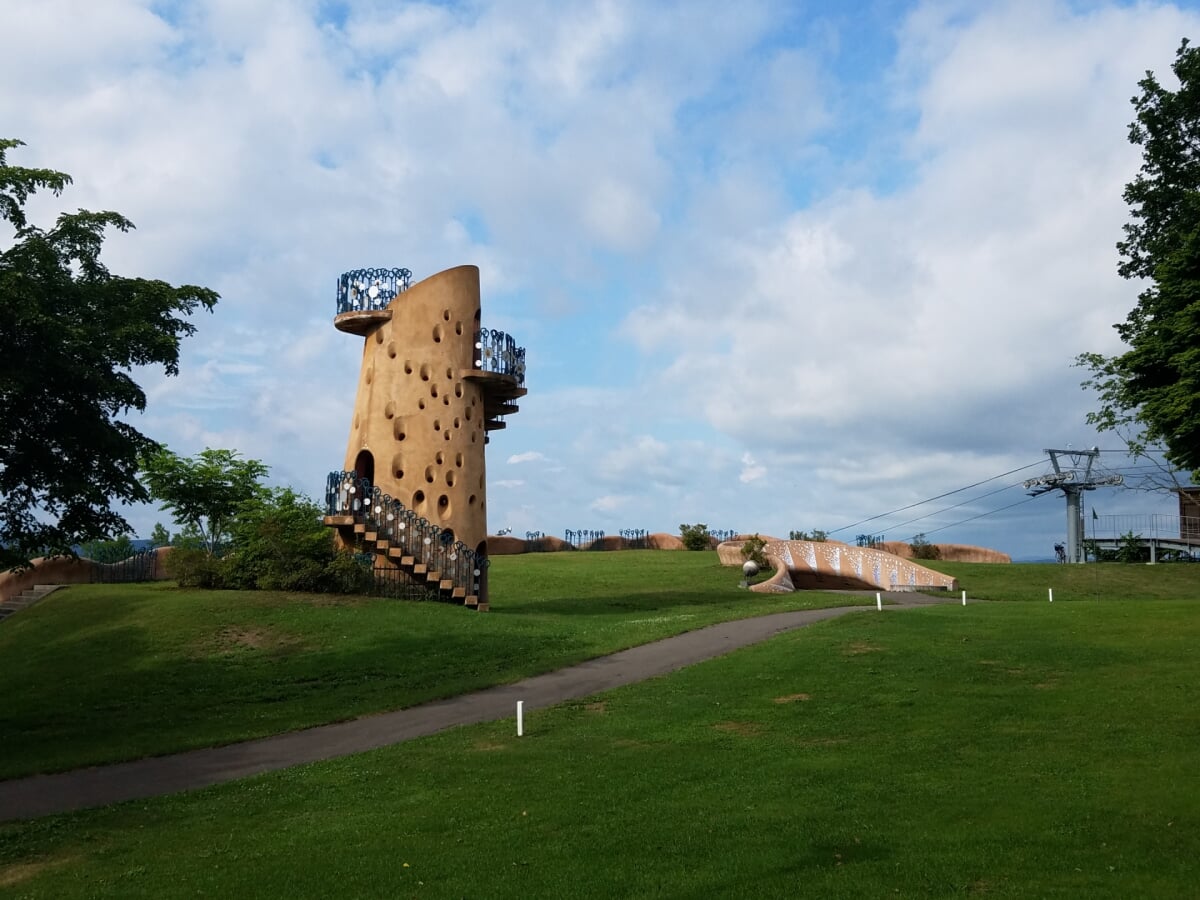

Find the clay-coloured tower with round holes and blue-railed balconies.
xmin=326 ymin=265 xmax=526 ymax=610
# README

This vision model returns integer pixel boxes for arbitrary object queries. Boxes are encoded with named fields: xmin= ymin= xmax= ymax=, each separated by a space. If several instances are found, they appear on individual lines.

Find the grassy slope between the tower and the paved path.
xmin=0 ymin=551 xmax=854 ymax=778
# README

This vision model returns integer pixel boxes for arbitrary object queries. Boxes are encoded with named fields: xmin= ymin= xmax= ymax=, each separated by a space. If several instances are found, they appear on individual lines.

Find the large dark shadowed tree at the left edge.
xmin=0 ymin=139 xmax=217 ymax=571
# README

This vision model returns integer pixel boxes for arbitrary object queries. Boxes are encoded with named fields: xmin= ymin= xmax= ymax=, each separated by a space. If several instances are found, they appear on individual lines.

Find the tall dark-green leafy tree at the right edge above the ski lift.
xmin=1078 ymin=40 xmax=1200 ymax=479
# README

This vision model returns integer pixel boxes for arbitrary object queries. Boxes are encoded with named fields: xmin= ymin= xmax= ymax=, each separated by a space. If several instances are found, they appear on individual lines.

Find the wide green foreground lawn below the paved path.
xmin=0 ymin=600 xmax=1200 ymax=900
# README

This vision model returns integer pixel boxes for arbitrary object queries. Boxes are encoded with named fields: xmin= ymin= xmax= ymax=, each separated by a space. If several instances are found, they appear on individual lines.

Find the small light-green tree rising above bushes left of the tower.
xmin=142 ymin=448 xmax=268 ymax=554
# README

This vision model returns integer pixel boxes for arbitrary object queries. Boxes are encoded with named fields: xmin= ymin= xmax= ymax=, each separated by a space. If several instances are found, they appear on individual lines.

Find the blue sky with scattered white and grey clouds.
xmin=0 ymin=0 xmax=1200 ymax=559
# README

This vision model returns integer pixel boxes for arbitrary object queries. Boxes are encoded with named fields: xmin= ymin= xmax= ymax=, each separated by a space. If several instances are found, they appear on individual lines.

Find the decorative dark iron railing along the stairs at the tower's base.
xmin=325 ymin=472 xmax=490 ymax=607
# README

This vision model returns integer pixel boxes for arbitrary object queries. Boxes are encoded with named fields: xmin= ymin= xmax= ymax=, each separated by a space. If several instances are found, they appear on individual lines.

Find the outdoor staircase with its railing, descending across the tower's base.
xmin=324 ymin=472 xmax=488 ymax=611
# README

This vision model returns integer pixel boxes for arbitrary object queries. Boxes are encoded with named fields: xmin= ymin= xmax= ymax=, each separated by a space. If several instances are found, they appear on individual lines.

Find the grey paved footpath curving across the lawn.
xmin=0 ymin=593 xmax=953 ymax=822
